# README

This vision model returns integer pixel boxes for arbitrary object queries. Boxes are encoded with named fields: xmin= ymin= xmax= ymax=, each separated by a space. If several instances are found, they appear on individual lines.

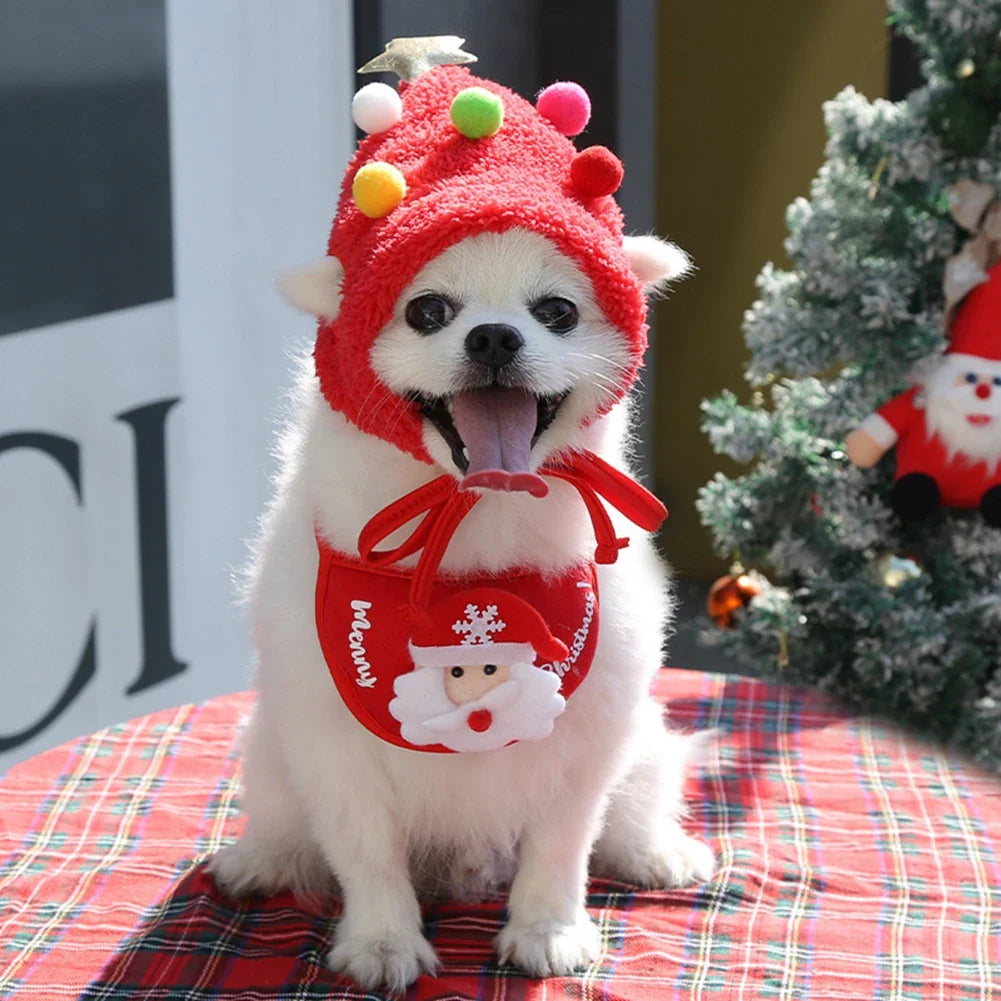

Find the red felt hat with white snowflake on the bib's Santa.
xmin=410 ymin=588 xmax=568 ymax=668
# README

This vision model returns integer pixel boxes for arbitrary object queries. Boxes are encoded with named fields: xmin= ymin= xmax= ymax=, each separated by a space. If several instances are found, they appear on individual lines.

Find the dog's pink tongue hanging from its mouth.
xmin=451 ymin=386 xmax=550 ymax=497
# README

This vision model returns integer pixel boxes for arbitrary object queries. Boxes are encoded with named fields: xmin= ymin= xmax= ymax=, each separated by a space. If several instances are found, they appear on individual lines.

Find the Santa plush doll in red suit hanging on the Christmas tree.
xmin=846 ymin=263 xmax=1001 ymax=528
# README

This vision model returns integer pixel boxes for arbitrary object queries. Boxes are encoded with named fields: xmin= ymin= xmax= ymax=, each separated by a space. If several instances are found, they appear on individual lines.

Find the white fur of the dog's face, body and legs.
xmin=211 ymin=231 xmax=713 ymax=990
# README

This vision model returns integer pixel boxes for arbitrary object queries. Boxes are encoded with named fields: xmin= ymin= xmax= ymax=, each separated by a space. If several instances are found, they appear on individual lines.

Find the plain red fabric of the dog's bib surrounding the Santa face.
xmin=316 ymin=540 xmax=598 ymax=752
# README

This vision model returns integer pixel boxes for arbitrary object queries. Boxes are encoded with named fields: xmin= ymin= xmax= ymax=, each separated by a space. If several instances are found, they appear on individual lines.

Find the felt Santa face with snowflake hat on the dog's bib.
xmin=389 ymin=588 xmax=569 ymax=751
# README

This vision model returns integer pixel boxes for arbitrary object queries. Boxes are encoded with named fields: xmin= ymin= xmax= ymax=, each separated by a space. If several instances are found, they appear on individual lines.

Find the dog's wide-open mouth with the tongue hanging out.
xmin=414 ymin=385 xmax=570 ymax=496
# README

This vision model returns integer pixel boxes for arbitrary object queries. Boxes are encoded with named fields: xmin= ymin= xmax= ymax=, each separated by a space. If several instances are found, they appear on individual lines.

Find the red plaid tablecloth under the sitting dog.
xmin=0 ymin=671 xmax=1001 ymax=1001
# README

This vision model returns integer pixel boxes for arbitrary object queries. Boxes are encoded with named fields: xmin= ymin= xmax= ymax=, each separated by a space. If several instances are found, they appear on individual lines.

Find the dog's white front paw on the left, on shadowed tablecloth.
xmin=326 ymin=932 xmax=438 ymax=994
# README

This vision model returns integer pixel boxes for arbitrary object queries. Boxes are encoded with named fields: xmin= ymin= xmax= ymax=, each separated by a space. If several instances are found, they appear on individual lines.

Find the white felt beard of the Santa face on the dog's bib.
xmin=389 ymin=664 xmax=567 ymax=751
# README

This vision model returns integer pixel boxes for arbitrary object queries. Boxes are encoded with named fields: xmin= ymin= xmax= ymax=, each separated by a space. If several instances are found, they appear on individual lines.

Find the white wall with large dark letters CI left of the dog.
xmin=0 ymin=0 xmax=354 ymax=770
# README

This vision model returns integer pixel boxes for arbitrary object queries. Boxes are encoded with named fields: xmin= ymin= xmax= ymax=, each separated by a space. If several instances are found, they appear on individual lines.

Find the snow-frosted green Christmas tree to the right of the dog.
xmin=699 ymin=0 xmax=1001 ymax=768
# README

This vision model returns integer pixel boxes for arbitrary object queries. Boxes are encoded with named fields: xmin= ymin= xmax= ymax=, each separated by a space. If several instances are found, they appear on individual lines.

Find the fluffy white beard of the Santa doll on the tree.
xmin=925 ymin=360 xmax=1001 ymax=466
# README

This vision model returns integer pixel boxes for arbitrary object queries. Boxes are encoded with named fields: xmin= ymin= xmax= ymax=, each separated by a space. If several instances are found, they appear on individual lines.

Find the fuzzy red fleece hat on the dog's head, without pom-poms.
xmin=314 ymin=66 xmax=647 ymax=462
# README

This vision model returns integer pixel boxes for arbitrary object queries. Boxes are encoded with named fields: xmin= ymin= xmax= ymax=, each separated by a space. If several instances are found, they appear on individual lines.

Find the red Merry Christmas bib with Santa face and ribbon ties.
xmin=316 ymin=452 xmax=667 ymax=753
